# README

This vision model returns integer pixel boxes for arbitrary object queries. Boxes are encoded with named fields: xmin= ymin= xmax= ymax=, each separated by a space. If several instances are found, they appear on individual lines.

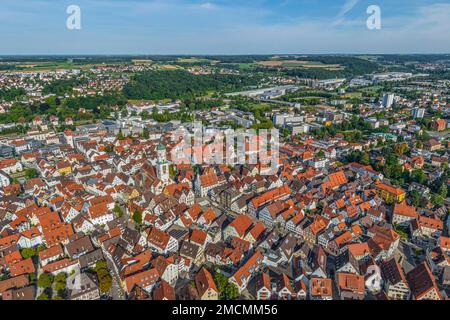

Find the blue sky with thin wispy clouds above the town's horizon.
xmin=0 ymin=0 xmax=450 ymax=55
